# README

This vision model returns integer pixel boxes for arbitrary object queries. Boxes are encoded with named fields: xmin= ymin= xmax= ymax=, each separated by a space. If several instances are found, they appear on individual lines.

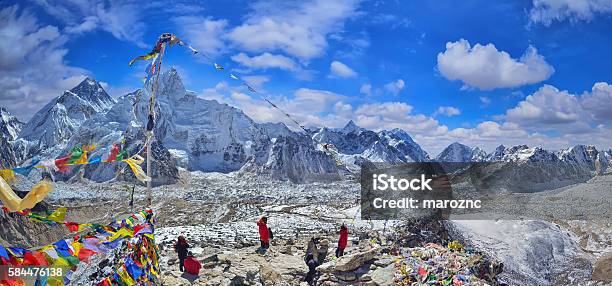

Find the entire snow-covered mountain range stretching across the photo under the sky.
xmin=0 ymin=69 xmax=612 ymax=184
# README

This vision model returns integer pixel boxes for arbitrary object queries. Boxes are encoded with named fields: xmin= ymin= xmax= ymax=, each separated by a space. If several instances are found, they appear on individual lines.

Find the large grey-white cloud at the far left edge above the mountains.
xmin=0 ymin=6 xmax=88 ymax=120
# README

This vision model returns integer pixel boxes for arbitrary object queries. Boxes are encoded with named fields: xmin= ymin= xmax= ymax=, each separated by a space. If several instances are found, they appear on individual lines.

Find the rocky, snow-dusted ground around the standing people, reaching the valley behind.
xmin=2 ymin=171 xmax=612 ymax=285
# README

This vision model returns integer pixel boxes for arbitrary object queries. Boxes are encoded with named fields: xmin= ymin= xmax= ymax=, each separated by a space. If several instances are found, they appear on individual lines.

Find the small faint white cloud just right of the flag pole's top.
xmin=174 ymin=16 xmax=227 ymax=56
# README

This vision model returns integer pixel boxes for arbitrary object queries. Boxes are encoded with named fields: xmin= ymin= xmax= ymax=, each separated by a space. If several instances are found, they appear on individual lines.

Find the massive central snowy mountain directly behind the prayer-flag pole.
xmin=56 ymin=69 xmax=338 ymax=183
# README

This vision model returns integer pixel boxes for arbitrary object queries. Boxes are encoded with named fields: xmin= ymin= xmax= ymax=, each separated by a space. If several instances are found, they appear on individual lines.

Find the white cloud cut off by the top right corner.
xmin=529 ymin=0 xmax=612 ymax=26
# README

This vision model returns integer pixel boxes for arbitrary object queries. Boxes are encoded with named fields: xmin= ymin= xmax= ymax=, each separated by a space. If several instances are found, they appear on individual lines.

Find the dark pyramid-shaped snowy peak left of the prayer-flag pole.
xmin=19 ymin=77 xmax=115 ymax=150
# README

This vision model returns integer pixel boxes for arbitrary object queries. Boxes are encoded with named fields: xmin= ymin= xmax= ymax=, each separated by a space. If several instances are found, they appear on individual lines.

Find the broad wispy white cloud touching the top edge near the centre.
xmin=228 ymin=0 xmax=357 ymax=60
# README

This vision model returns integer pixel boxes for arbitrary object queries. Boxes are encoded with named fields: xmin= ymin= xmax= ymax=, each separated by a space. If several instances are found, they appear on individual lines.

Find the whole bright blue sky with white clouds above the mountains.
xmin=0 ymin=0 xmax=612 ymax=154
